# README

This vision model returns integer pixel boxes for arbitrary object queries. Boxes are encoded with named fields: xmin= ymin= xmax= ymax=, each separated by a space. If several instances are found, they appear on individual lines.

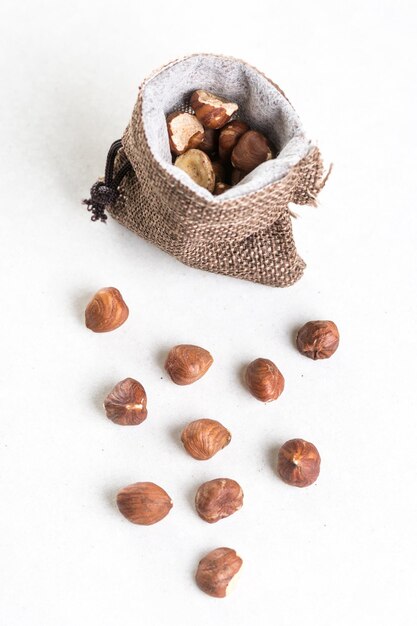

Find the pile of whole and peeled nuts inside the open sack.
xmin=166 ymin=89 xmax=276 ymax=195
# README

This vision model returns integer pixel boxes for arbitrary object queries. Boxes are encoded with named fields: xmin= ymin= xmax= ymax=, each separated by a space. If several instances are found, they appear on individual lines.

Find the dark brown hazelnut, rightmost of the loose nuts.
xmin=297 ymin=320 xmax=339 ymax=360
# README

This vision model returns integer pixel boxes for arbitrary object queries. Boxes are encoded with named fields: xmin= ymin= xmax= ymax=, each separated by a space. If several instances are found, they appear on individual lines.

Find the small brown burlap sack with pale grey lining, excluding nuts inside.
xmin=86 ymin=54 xmax=326 ymax=287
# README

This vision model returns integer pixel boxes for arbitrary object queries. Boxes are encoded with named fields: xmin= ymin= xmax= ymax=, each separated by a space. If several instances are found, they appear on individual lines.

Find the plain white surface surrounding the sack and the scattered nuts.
xmin=0 ymin=0 xmax=417 ymax=626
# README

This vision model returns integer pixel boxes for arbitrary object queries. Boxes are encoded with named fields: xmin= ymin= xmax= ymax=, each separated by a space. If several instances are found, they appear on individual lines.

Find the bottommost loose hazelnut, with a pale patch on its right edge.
xmin=195 ymin=548 xmax=243 ymax=598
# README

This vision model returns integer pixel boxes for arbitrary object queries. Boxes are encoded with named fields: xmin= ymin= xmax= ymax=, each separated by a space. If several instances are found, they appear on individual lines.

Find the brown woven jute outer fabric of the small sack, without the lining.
xmin=109 ymin=54 xmax=325 ymax=287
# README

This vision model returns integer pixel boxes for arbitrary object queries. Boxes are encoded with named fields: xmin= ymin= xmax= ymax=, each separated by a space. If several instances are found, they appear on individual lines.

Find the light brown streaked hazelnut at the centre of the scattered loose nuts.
xmin=181 ymin=419 xmax=232 ymax=461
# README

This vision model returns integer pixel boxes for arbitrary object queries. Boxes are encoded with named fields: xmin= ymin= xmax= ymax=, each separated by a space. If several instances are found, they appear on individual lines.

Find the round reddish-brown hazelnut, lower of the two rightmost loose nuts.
xmin=278 ymin=439 xmax=320 ymax=487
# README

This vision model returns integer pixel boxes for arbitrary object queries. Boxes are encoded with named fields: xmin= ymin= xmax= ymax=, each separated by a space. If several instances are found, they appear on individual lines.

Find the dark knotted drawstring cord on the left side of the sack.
xmin=83 ymin=139 xmax=132 ymax=224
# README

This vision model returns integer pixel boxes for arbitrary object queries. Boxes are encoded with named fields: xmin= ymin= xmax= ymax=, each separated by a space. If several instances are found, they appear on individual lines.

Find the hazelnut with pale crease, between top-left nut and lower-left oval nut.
xmin=104 ymin=378 xmax=148 ymax=426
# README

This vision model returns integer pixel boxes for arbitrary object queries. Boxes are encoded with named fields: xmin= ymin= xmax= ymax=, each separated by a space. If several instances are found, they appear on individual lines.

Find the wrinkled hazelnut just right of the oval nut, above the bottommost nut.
xmin=195 ymin=478 xmax=243 ymax=524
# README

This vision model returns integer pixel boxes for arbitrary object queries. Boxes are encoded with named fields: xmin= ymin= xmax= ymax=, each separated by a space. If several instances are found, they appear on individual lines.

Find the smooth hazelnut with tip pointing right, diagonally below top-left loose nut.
xmin=165 ymin=344 xmax=213 ymax=385
